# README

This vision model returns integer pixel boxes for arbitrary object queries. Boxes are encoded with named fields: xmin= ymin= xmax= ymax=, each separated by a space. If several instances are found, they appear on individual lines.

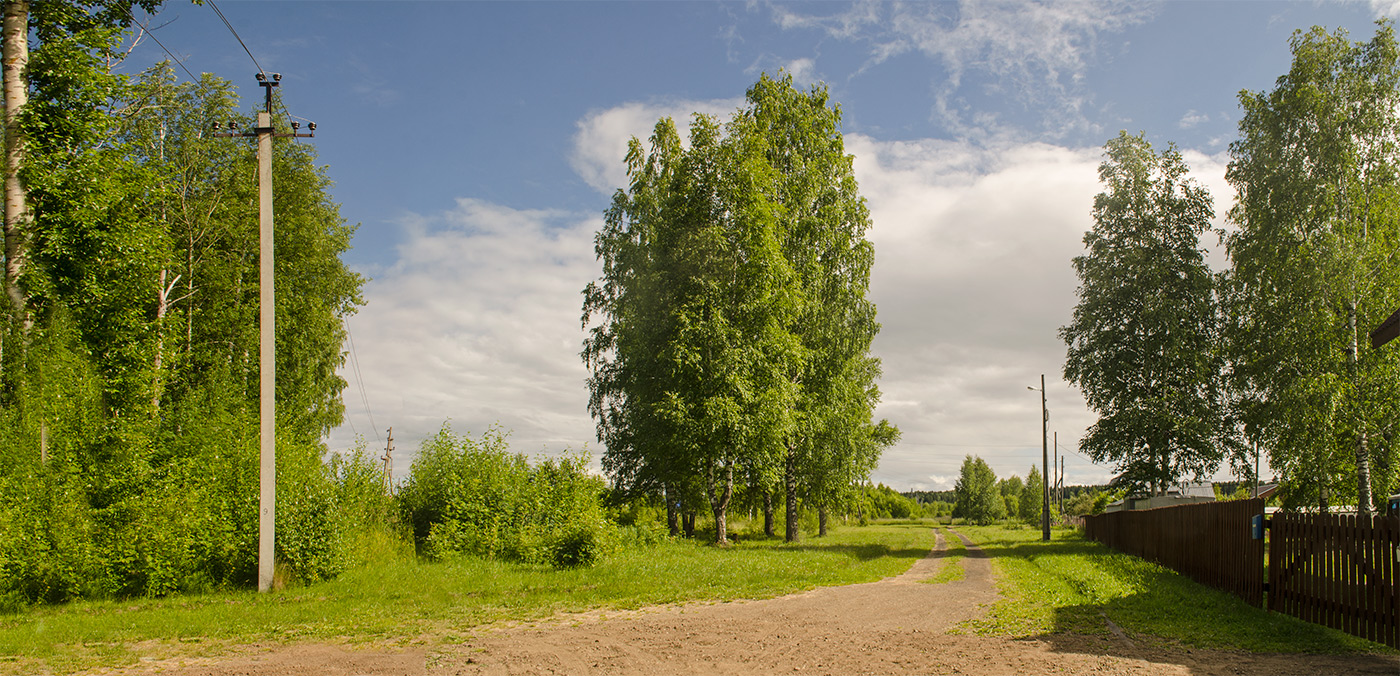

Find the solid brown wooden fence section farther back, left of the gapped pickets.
xmin=1084 ymin=498 xmax=1264 ymax=606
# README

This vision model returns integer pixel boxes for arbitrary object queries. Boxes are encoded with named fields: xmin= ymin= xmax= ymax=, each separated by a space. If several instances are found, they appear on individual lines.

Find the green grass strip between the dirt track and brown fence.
xmin=959 ymin=526 xmax=1394 ymax=654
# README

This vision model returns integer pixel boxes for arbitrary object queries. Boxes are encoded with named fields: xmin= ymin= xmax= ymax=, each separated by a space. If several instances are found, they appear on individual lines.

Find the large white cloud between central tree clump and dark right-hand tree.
xmin=847 ymin=134 xmax=1107 ymax=490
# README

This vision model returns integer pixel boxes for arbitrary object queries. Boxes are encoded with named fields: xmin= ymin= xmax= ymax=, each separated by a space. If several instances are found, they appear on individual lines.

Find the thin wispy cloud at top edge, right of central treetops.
xmin=773 ymin=0 xmax=1152 ymax=136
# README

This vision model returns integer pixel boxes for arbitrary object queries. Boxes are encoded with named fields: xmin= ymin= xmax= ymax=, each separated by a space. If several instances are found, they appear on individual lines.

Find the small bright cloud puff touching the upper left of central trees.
xmin=570 ymin=98 xmax=743 ymax=195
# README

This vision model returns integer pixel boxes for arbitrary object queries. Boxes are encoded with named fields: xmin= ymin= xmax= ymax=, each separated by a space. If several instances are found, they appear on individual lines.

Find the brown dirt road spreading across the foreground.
xmin=119 ymin=535 xmax=1400 ymax=676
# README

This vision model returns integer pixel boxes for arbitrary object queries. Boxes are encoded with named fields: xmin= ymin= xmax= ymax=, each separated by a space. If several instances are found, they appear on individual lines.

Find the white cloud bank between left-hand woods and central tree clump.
xmin=330 ymin=199 xmax=601 ymax=476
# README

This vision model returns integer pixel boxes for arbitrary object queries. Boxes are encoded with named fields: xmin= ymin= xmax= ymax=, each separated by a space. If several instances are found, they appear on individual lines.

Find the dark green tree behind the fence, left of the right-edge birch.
xmin=1060 ymin=133 xmax=1238 ymax=493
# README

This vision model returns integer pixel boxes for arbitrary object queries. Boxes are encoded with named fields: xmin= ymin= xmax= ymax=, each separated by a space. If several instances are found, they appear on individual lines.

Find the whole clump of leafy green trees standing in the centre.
xmin=582 ymin=76 xmax=897 ymax=542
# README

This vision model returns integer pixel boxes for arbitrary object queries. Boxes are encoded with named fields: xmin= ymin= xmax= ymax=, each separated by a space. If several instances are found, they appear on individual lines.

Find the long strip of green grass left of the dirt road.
xmin=0 ymin=523 xmax=934 ymax=673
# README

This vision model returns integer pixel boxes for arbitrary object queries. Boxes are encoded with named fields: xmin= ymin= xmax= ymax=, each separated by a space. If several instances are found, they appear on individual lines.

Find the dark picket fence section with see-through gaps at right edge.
xmin=1268 ymin=512 xmax=1400 ymax=648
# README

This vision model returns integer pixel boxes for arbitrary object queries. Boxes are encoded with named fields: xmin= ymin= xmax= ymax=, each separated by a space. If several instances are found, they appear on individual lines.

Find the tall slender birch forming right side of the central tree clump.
xmin=741 ymin=74 xmax=899 ymax=542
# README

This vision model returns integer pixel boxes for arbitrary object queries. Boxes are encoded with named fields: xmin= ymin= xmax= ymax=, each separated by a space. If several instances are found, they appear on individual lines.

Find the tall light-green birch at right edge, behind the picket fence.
xmin=1225 ymin=21 xmax=1400 ymax=512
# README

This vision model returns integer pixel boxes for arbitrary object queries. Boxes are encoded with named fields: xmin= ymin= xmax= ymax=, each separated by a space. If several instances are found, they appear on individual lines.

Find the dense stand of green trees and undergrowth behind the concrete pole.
xmin=0 ymin=42 xmax=363 ymax=600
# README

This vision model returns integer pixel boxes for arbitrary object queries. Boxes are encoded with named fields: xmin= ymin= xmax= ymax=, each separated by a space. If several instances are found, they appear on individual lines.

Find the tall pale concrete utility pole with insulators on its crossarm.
xmin=214 ymin=73 xmax=316 ymax=592
